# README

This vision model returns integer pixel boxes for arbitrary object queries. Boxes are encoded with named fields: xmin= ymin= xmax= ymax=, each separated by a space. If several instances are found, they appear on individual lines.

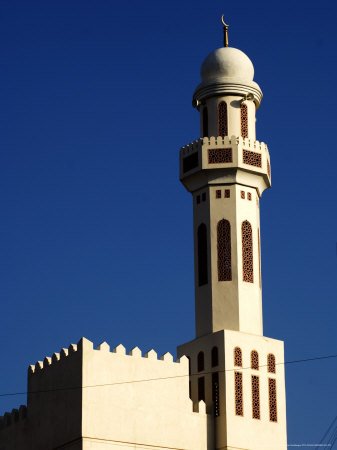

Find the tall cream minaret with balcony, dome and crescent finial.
xmin=178 ymin=22 xmax=287 ymax=450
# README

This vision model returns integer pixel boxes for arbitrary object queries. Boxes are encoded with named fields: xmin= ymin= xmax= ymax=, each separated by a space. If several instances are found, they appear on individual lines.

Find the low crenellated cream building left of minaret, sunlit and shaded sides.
xmin=0 ymin=338 xmax=211 ymax=450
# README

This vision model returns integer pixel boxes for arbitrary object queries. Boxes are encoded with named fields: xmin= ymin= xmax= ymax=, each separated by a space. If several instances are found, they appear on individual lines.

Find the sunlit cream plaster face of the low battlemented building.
xmin=82 ymin=341 xmax=207 ymax=450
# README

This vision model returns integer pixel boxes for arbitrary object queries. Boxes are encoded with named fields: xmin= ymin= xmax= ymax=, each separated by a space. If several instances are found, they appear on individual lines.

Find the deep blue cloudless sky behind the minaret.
xmin=0 ymin=0 xmax=337 ymax=444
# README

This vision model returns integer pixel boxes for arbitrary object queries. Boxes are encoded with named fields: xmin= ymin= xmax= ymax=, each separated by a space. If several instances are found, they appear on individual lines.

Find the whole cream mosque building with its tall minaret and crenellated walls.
xmin=0 ymin=23 xmax=287 ymax=450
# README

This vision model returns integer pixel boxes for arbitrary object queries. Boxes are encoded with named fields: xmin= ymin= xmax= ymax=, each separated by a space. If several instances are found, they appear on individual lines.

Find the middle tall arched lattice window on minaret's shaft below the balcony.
xmin=217 ymin=219 xmax=232 ymax=281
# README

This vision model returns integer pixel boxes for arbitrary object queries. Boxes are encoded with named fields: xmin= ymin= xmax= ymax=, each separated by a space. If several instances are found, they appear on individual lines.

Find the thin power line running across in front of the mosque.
xmin=0 ymin=354 xmax=337 ymax=397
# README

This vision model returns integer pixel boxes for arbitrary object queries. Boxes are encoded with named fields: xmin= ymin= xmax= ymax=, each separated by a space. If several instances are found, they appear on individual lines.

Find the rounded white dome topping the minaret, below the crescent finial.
xmin=201 ymin=47 xmax=254 ymax=81
